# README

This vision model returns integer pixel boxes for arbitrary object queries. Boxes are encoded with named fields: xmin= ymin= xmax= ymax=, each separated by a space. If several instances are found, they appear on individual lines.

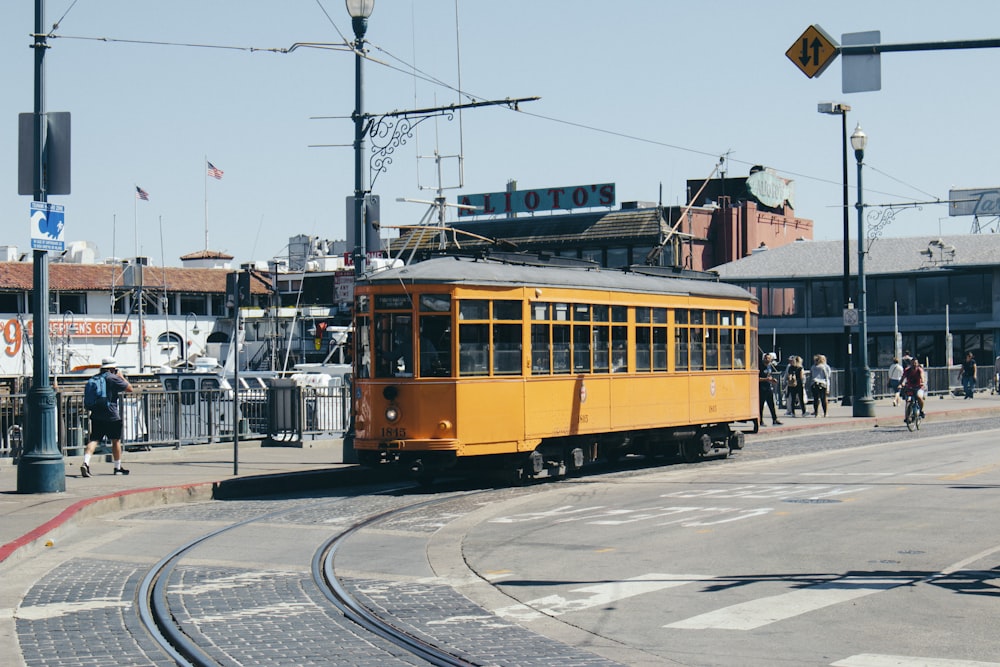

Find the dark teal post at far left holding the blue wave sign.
xmin=17 ymin=0 xmax=66 ymax=493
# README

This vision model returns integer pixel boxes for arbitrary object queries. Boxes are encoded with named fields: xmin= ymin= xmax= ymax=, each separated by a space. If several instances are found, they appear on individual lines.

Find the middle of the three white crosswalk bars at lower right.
xmin=663 ymin=577 xmax=915 ymax=630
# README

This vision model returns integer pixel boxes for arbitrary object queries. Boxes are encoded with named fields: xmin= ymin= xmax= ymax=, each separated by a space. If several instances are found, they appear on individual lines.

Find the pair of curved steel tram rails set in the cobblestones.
xmin=137 ymin=487 xmax=487 ymax=667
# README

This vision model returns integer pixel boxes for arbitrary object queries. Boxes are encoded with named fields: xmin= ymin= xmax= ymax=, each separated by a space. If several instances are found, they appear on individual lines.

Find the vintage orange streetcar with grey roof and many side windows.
xmin=353 ymin=256 xmax=757 ymax=480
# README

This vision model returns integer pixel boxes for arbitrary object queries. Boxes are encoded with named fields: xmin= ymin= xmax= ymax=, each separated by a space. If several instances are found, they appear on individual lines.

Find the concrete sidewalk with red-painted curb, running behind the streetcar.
xmin=0 ymin=391 xmax=1000 ymax=563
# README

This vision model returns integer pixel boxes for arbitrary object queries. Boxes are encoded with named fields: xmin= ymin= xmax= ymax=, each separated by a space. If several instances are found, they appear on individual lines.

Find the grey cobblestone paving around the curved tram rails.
xmin=15 ymin=490 xmax=616 ymax=667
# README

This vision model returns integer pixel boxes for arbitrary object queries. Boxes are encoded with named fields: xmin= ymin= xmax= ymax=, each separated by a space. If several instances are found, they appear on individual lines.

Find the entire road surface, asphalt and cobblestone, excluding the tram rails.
xmin=7 ymin=418 xmax=1000 ymax=667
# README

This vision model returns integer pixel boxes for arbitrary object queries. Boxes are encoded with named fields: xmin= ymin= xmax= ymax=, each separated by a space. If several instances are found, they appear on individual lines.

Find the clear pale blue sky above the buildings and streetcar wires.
xmin=0 ymin=0 xmax=1000 ymax=265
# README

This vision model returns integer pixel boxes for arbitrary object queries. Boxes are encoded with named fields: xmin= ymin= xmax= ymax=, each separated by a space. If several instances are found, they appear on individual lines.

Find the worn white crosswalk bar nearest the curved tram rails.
xmin=495 ymin=573 xmax=713 ymax=621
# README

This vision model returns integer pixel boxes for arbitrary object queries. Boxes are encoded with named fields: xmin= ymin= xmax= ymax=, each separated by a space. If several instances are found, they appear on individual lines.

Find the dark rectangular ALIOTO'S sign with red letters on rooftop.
xmin=458 ymin=183 xmax=615 ymax=218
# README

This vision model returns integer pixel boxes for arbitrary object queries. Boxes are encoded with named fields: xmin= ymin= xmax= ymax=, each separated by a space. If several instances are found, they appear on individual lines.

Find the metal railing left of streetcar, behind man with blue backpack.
xmin=0 ymin=386 xmax=350 ymax=459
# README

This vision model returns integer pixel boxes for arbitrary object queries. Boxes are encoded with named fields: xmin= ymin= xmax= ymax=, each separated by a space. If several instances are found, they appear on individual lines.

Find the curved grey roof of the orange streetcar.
xmin=363 ymin=256 xmax=754 ymax=300
